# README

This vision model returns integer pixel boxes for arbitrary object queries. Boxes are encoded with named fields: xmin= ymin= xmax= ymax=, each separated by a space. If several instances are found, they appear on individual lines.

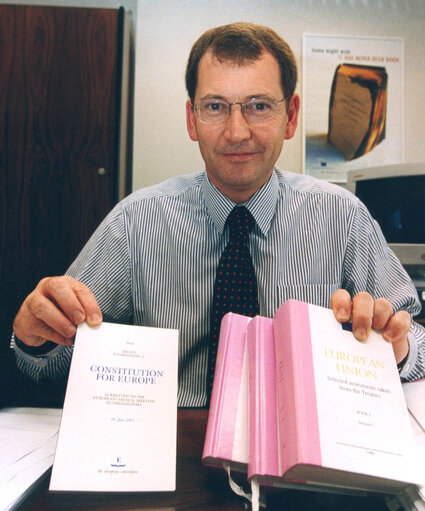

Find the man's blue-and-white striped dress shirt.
xmin=15 ymin=169 xmax=425 ymax=407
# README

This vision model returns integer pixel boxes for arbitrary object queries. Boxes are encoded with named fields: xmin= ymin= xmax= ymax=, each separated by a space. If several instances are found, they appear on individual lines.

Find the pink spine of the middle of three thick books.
xmin=247 ymin=316 xmax=279 ymax=478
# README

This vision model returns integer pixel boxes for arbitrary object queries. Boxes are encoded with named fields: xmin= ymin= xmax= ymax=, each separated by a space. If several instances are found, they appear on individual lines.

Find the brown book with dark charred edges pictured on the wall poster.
xmin=328 ymin=64 xmax=388 ymax=161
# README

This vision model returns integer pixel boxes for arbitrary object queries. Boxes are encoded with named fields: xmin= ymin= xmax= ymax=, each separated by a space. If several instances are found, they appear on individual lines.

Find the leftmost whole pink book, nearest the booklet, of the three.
xmin=202 ymin=312 xmax=251 ymax=472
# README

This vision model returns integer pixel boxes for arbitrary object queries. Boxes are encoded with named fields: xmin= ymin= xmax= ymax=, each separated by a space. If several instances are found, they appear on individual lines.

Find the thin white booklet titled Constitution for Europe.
xmin=50 ymin=323 xmax=178 ymax=492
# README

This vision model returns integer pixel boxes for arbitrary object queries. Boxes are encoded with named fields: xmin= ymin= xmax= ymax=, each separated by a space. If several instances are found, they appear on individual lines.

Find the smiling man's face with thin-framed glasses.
xmin=186 ymin=52 xmax=299 ymax=202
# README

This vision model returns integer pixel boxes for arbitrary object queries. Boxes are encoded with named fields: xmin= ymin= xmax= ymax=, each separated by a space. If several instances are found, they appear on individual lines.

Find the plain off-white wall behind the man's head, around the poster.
xmin=133 ymin=0 xmax=425 ymax=189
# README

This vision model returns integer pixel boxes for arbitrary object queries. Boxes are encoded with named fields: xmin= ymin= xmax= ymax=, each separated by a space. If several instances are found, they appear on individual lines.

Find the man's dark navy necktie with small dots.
xmin=207 ymin=206 xmax=259 ymax=399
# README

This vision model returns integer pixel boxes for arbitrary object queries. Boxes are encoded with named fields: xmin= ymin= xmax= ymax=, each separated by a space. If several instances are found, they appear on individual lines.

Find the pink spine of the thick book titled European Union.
xmin=273 ymin=300 xmax=322 ymax=473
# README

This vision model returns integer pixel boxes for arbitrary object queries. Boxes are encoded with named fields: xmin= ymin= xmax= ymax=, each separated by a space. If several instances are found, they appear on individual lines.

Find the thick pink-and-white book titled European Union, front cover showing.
xmin=273 ymin=300 xmax=418 ymax=493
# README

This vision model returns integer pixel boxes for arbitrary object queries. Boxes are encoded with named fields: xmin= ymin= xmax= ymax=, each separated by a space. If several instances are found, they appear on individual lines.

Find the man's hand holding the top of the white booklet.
xmin=13 ymin=276 xmax=102 ymax=346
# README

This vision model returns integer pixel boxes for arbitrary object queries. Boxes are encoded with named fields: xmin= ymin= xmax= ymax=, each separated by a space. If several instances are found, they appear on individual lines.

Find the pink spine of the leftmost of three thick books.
xmin=202 ymin=312 xmax=250 ymax=461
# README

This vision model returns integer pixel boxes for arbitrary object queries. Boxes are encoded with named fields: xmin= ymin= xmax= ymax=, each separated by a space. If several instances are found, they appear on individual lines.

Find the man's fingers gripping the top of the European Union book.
xmin=330 ymin=289 xmax=411 ymax=363
